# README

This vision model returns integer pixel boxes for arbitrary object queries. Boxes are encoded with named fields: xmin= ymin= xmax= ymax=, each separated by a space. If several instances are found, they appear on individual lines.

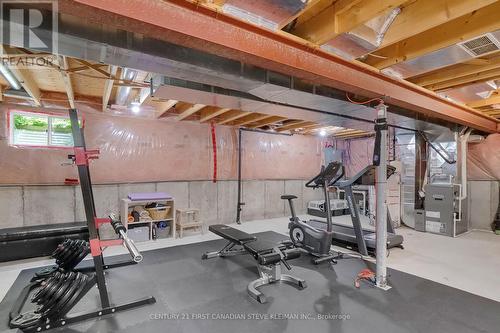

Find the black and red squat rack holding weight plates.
xmin=9 ymin=109 xmax=156 ymax=333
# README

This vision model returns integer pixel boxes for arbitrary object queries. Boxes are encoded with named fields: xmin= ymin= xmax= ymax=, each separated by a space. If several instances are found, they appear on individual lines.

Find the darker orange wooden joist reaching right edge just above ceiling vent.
xmin=365 ymin=1 xmax=500 ymax=69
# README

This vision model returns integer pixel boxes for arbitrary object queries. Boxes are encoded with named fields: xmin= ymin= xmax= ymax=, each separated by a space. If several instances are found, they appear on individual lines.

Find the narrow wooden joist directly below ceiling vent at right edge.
xmin=407 ymin=56 xmax=500 ymax=86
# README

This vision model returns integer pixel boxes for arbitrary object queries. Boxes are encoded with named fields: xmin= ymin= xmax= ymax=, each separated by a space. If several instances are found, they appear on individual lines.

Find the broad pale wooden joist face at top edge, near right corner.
xmin=374 ymin=0 xmax=496 ymax=47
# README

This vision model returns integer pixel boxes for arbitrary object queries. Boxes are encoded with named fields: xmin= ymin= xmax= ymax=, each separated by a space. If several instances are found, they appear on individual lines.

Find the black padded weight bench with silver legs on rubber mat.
xmin=201 ymin=224 xmax=306 ymax=303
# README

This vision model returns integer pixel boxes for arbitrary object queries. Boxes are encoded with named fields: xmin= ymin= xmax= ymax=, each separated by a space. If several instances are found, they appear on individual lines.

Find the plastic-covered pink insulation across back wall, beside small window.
xmin=0 ymin=108 xmax=321 ymax=184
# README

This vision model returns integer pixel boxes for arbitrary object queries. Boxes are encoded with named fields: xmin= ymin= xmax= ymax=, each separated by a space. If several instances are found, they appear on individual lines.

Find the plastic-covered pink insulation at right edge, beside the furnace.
xmin=467 ymin=133 xmax=500 ymax=180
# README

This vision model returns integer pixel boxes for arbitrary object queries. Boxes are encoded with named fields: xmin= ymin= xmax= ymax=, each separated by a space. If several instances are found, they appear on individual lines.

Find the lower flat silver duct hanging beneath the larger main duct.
xmin=155 ymin=77 xmax=454 ymax=138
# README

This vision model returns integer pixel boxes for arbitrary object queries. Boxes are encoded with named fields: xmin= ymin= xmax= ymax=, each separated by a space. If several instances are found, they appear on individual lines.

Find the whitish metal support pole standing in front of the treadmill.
xmin=375 ymin=103 xmax=390 ymax=290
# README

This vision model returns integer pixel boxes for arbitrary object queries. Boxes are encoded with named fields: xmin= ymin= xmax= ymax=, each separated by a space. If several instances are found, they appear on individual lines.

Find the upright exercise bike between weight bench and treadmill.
xmin=281 ymin=162 xmax=344 ymax=265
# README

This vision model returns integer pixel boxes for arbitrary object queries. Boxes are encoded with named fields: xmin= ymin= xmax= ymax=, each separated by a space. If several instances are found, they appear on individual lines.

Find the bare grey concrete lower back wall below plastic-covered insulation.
xmin=0 ymin=179 xmax=322 ymax=228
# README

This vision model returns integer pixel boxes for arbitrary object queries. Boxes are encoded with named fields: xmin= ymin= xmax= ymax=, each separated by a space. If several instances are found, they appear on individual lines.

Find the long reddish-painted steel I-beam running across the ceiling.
xmin=59 ymin=0 xmax=499 ymax=133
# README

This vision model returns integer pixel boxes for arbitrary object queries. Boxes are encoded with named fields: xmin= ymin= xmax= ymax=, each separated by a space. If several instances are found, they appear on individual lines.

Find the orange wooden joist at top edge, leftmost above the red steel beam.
xmin=291 ymin=0 xmax=407 ymax=45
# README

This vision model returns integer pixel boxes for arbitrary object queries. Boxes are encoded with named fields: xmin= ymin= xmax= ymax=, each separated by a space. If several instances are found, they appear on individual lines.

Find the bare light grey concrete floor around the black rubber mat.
xmin=0 ymin=216 xmax=500 ymax=302
